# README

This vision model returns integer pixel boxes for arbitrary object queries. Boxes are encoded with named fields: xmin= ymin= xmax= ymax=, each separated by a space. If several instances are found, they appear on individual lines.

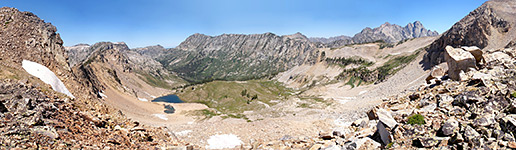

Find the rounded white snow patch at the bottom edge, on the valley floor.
xmin=206 ymin=134 xmax=243 ymax=149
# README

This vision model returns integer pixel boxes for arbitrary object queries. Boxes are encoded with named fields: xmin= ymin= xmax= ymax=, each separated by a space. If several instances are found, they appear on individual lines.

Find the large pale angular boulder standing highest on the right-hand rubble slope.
xmin=444 ymin=46 xmax=476 ymax=80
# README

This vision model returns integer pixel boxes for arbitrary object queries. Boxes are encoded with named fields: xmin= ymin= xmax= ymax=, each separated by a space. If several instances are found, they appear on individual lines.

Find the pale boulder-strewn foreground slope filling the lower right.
xmin=249 ymin=47 xmax=516 ymax=149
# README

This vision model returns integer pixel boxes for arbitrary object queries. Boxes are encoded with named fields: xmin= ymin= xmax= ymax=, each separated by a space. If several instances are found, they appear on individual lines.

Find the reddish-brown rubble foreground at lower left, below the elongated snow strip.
xmin=0 ymin=79 xmax=194 ymax=149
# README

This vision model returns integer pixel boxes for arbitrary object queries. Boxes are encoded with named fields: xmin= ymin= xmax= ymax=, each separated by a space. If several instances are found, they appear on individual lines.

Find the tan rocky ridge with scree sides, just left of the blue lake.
xmin=70 ymin=42 xmax=184 ymax=99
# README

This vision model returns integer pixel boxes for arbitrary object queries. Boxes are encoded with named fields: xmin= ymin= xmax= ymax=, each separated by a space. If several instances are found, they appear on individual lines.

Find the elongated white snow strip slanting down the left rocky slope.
xmin=22 ymin=60 xmax=75 ymax=98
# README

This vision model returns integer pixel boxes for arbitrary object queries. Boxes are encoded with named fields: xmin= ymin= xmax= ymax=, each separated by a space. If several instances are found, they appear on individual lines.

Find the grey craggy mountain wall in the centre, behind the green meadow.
xmin=158 ymin=33 xmax=318 ymax=81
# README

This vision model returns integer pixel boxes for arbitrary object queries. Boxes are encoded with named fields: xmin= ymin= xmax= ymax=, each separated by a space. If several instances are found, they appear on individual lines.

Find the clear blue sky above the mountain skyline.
xmin=0 ymin=0 xmax=485 ymax=48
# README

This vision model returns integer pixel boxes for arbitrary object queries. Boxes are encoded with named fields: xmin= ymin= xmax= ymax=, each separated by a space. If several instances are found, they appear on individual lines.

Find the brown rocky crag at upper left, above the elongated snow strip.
xmin=0 ymin=7 xmax=70 ymax=75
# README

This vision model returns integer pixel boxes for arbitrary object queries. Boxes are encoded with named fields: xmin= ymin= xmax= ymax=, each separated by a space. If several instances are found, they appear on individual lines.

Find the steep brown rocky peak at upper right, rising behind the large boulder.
xmin=426 ymin=0 xmax=516 ymax=68
